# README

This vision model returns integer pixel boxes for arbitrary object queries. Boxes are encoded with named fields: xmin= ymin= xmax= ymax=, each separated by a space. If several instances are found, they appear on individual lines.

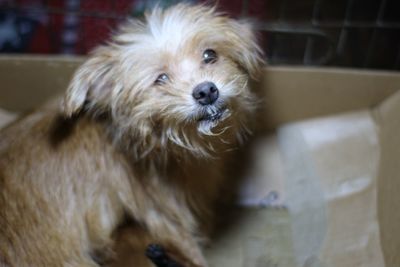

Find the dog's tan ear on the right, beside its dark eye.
xmin=227 ymin=19 xmax=265 ymax=79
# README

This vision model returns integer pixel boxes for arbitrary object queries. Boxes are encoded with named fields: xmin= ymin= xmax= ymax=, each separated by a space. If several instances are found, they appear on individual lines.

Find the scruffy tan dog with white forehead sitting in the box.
xmin=0 ymin=4 xmax=264 ymax=267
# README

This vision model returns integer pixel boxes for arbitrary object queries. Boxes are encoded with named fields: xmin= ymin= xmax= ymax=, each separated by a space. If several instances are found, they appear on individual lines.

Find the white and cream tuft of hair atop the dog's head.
xmin=136 ymin=5 xmax=228 ymax=55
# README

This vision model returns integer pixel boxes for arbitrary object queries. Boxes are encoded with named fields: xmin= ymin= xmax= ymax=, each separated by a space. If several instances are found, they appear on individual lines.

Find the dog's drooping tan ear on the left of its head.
xmin=62 ymin=46 xmax=117 ymax=117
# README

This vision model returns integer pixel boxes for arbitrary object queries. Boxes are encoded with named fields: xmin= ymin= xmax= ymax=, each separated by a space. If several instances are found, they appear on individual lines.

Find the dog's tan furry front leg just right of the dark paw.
xmin=117 ymin=174 xmax=208 ymax=267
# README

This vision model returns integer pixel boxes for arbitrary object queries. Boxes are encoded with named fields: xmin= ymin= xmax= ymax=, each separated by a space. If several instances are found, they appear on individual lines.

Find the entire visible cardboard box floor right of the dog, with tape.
xmin=216 ymin=110 xmax=388 ymax=267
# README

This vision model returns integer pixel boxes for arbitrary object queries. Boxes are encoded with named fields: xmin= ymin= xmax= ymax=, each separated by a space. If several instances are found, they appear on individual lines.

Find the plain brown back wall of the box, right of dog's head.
xmin=261 ymin=67 xmax=400 ymax=128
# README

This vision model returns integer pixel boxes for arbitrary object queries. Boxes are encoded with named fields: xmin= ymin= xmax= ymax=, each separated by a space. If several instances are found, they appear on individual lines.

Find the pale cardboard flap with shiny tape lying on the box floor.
xmin=278 ymin=110 xmax=384 ymax=267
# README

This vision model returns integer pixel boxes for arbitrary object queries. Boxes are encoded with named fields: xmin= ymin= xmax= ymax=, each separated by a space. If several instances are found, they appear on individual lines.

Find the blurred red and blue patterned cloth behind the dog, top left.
xmin=0 ymin=0 xmax=247 ymax=54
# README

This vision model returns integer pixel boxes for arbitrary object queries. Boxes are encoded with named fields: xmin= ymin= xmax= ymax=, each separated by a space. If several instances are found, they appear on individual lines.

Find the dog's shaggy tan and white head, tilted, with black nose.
xmin=63 ymin=5 xmax=262 ymax=158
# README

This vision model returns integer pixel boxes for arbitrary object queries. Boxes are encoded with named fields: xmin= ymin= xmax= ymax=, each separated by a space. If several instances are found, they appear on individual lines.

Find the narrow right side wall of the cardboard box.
xmin=375 ymin=93 xmax=400 ymax=267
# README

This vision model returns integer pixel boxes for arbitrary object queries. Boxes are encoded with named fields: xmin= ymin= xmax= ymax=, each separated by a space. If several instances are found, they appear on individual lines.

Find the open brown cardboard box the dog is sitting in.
xmin=0 ymin=56 xmax=400 ymax=267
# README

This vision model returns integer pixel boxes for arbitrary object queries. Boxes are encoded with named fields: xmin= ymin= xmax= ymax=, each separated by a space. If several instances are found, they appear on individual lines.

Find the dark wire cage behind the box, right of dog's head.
xmin=259 ymin=0 xmax=400 ymax=70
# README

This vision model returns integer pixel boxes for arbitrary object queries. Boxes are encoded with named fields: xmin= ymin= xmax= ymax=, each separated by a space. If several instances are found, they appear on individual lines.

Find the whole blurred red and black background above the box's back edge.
xmin=0 ymin=0 xmax=400 ymax=70
